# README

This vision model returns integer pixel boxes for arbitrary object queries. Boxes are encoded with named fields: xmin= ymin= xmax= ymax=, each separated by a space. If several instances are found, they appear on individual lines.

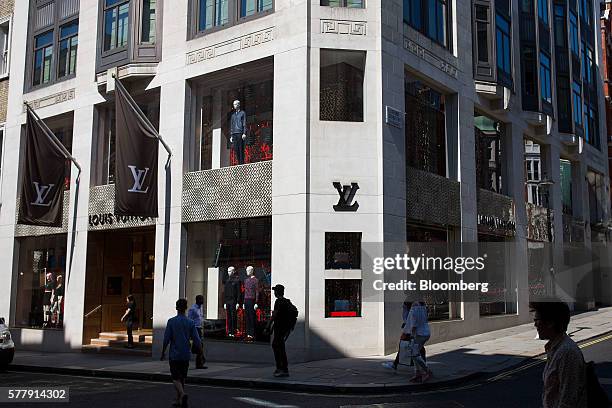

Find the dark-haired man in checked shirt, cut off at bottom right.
xmin=530 ymin=301 xmax=587 ymax=408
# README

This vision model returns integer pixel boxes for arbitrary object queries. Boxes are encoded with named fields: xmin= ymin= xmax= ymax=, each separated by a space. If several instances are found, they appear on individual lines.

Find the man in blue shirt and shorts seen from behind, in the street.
xmin=160 ymin=299 xmax=202 ymax=407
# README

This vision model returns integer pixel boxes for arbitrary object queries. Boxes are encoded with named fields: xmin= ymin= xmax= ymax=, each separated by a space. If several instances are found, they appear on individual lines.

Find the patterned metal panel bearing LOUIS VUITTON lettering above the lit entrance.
xmin=88 ymin=184 xmax=156 ymax=231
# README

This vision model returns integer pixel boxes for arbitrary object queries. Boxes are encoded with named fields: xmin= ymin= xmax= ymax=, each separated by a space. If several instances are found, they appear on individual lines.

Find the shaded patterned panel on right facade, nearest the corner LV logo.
xmin=406 ymin=167 xmax=461 ymax=226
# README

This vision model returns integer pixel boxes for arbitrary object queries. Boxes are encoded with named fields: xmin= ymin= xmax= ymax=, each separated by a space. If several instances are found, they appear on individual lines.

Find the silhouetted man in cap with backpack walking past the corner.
xmin=266 ymin=285 xmax=297 ymax=377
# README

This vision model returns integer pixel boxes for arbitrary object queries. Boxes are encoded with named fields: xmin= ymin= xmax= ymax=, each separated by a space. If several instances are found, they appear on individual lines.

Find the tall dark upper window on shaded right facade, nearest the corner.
xmin=404 ymin=78 xmax=446 ymax=177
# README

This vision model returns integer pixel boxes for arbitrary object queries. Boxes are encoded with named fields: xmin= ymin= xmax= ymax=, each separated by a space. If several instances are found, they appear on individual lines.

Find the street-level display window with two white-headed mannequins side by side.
xmin=186 ymin=217 xmax=272 ymax=342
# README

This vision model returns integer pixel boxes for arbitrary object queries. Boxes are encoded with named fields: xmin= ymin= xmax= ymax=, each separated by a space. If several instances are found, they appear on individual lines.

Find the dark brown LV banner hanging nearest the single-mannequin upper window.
xmin=115 ymin=80 xmax=159 ymax=217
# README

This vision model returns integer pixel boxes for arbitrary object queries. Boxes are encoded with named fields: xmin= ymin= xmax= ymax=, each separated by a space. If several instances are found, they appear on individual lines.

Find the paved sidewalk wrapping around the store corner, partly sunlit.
xmin=12 ymin=308 xmax=612 ymax=393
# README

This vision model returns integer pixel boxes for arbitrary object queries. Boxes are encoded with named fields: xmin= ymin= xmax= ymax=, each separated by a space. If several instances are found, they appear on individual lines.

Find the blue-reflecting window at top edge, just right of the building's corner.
xmin=404 ymin=0 xmax=449 ymax=47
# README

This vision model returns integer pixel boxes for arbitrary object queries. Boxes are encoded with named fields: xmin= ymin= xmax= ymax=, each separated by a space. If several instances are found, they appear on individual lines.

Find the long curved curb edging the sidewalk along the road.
xmin=8 ymin=330 xmax=612 ymax=394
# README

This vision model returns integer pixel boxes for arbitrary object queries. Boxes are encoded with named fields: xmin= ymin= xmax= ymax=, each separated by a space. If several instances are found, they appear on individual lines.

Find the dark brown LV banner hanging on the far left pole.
xmin=18 ymin=110 xmax=66 ymax=227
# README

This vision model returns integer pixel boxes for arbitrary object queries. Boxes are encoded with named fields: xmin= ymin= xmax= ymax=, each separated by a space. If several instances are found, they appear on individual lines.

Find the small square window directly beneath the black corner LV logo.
xmin=325 ymin=232 xmax=361 ymax=269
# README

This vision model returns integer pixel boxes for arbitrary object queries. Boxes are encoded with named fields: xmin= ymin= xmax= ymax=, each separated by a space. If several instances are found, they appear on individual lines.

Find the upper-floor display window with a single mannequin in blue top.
xmin=190 ymin=58 xmax=274 ymax=171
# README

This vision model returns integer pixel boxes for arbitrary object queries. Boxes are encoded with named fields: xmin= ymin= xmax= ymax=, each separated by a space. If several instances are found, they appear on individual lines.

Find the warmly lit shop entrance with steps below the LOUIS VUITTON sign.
xmin=83 ymin=228 xmax=155 ymax=352
